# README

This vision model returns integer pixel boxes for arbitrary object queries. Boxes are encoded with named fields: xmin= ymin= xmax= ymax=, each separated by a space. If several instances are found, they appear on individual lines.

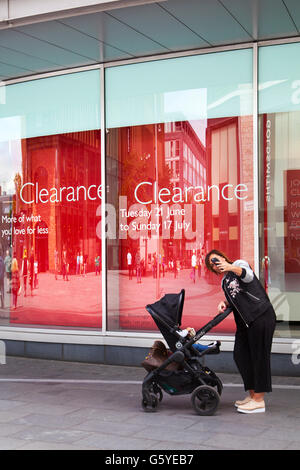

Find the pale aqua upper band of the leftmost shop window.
xmin=0 ymin=70 xmax=100 ymax=141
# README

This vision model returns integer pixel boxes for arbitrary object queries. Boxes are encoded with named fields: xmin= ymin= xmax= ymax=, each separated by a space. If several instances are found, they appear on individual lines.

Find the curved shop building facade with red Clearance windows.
xmin=0 ymin=0 xmax=300 ymax=375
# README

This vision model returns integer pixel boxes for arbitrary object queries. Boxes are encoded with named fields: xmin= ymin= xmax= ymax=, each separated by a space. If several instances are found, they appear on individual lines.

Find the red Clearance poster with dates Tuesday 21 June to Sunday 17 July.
xmin=107 ymin=117 xmax=254 ymax=333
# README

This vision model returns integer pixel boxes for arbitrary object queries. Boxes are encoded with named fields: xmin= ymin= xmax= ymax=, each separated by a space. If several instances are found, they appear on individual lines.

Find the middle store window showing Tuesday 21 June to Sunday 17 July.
xmin=105 ymin=49 xmax=254 ymax=334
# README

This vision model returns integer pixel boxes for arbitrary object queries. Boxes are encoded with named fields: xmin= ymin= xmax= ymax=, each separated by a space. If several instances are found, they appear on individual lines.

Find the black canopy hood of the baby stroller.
xmin=146 ymin=289 xmax=185 ymax=351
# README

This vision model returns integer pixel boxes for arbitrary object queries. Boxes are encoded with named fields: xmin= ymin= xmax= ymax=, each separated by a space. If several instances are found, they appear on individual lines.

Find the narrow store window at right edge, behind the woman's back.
xmin=259 ymin=43 xmax=300 ymax=337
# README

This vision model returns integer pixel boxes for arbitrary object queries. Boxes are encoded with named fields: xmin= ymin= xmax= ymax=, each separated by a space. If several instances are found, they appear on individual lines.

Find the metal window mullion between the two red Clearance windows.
xmin=100 ymin=66 xmax=107 ymax=334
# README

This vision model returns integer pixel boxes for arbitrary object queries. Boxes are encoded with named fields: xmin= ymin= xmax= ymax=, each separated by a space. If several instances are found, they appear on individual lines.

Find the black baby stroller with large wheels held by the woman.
xmin=142 ymin=289 xmax=231 ymax=416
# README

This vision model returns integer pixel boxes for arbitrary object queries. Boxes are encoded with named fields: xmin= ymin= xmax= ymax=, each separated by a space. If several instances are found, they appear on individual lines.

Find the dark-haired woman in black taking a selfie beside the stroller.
xmin=205 ymin=250 xmax=276 ymax=413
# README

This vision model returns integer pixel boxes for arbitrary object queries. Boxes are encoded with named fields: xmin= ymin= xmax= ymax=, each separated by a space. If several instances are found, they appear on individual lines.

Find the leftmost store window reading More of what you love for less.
xmin=0 ymin=71 xmax=102 ymax=329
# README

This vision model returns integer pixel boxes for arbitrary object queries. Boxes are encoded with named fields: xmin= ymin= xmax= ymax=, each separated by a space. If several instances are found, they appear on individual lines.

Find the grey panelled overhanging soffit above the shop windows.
xmin=0 ymin=0 xmax=300 ymax=81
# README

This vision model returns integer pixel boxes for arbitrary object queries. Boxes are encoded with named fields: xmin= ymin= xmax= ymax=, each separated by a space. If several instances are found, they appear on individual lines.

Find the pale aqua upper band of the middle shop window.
xmin=105 ymin=49 xmax=252 ymax=128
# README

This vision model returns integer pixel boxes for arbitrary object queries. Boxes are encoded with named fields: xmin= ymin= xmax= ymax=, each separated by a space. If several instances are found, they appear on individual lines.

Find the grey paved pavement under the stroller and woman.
xmin=0 ymin=357 xmax=300 ymax=452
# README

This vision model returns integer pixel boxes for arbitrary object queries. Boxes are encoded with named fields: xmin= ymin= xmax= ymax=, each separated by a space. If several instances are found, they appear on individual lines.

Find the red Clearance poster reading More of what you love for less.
xmin=1 ymin=130 xmax=102 ymax=328
